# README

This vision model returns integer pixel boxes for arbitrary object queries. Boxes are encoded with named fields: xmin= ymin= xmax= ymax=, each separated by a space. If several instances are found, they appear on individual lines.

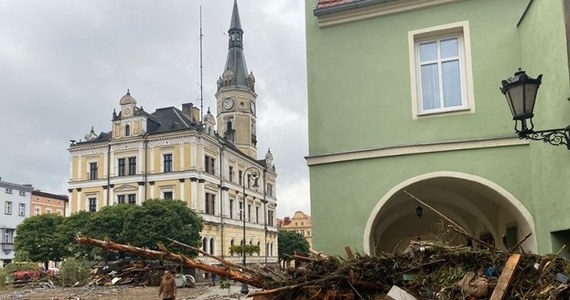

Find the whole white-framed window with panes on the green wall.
xmin=408 ymin=22 xmax=474 ymax=117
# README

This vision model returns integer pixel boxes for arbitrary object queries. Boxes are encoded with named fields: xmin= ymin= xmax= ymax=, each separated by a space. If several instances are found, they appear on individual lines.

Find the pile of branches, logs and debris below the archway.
xmin=78 ymin=237 xmax=570 ymax=299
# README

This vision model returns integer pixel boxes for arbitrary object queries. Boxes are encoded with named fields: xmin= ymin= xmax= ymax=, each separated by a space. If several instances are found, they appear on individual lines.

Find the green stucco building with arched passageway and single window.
xmin=306 ymin=0 xmax=570 ymax=256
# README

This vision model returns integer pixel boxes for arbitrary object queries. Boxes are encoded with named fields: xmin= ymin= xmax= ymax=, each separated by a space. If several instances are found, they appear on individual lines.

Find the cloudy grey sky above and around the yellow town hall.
xmin=0 ymin=0 xmax=310 ymax=217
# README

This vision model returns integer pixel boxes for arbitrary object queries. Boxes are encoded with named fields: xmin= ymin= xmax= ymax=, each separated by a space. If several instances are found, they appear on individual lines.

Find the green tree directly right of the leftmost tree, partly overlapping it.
xmin=56 ymin=211 xmax=94 ymax=257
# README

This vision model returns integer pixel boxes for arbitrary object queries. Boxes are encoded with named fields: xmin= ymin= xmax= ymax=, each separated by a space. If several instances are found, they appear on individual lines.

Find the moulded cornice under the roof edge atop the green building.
xmin=314 ymin=0 xmax=465 ymax=27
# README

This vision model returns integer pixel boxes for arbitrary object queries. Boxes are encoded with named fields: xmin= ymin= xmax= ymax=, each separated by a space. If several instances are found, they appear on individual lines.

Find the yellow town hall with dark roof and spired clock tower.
xmin=66 ymin=2 xmax=277 ymax=263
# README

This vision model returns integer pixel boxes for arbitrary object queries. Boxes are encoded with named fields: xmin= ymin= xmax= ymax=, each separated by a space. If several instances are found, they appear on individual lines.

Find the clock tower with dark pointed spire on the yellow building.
xmin=216 ymin=0 xmax=257 ymax=159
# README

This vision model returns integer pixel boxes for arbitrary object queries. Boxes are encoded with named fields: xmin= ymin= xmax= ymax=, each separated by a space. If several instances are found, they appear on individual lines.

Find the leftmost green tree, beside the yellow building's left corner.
xmin=14 ymin=214 xmax=65 ymax=269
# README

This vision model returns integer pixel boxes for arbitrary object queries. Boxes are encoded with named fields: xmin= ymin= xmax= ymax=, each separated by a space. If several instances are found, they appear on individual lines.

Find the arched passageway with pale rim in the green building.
xmin=363 ymin=172 xmax=537 ymax=254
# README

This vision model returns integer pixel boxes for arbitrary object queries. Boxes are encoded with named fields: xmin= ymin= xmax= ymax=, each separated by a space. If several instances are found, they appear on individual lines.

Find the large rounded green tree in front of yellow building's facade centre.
xmin=123 ymin=199 xmax=202 ymax=256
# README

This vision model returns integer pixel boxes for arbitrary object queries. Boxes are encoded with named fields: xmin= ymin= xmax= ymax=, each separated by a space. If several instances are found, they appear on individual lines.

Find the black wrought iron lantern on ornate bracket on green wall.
xmin=500 ymin=68 xmax=570 ymax=150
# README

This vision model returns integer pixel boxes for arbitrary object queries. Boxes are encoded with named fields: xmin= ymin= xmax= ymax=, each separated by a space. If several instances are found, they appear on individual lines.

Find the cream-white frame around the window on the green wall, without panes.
xmin=408 ymin=21 xmax=475 ymax=119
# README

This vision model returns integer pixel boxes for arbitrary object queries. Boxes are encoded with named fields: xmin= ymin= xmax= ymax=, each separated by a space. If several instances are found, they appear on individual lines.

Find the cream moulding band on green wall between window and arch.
xmin=305 ymin=137 xmax=529 ymax=166
